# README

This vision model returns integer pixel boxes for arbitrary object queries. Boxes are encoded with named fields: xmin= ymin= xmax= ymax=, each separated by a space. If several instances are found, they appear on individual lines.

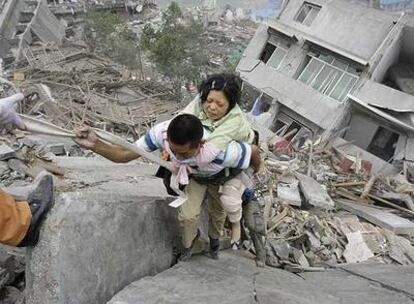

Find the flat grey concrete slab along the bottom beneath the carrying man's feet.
xmin=108 ymin=251 xmax=413 ymax=304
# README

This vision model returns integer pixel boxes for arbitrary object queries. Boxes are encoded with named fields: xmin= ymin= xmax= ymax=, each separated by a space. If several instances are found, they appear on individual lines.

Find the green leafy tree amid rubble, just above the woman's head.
xmin=141 ymin=1 xmax=208 ymax=88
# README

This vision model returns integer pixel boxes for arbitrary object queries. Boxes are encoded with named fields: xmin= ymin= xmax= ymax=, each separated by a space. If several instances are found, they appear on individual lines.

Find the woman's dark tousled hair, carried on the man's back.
xmin=198 ymin=73 xmax=241 ymax=111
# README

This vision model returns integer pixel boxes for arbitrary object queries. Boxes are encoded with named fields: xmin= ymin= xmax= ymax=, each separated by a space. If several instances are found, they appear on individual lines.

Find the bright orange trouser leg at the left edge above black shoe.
xmin=0 ymin=189 xmax=32 ymax=246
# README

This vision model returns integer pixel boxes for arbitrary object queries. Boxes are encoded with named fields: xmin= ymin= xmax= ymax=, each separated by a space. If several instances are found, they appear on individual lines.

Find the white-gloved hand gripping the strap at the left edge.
xmin=0 ymin=93 xmax=26 ymax=133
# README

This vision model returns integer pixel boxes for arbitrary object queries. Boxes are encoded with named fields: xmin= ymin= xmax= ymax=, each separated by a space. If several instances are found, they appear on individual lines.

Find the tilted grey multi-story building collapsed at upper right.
xmin=237 ymin=0 xmax=414 ymax=172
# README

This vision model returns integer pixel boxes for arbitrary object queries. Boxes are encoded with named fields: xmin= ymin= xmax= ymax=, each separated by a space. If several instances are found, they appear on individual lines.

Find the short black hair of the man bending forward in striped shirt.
xmin=167 ymin=114 xmax=204 ymax=148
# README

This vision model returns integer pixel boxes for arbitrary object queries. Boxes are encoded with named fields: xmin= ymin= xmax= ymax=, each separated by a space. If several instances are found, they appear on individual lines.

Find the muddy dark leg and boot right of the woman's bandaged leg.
xmin=243 ymin=199 xmax=266 ymax=267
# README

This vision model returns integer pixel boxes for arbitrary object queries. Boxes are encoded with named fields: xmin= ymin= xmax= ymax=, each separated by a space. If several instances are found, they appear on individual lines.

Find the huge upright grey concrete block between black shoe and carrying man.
xmin=26 ymin=158 xmax=178 ymax=304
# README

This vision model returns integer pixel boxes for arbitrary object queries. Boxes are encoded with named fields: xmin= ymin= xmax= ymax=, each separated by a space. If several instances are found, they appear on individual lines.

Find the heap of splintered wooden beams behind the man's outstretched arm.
xmin=3 ymin=45 xmax=180 ymax=138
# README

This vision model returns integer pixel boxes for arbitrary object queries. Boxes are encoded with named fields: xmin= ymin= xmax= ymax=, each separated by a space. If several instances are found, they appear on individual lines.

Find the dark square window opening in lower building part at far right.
xmin=367 ymin=127 xmax=399 ymax=161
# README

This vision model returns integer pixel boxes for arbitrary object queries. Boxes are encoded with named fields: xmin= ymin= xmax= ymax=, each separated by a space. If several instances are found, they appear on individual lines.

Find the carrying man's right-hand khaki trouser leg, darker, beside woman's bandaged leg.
xmin=207 ymin=185 xmax=226 ymax=259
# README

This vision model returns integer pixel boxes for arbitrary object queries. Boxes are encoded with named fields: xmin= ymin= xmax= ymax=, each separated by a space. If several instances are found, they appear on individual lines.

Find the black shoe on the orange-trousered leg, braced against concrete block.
xmin=18 ymin=173 xmax=54 ymax=247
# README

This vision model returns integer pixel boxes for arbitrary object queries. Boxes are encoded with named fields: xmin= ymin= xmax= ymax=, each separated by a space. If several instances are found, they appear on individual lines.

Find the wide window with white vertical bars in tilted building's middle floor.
xmin=298 ymin=53 xmax=359 ymax=101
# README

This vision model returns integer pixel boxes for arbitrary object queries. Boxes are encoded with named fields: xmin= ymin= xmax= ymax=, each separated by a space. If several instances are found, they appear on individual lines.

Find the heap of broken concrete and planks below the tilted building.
xmin=257 ymin=137 xmax=414 ymax=272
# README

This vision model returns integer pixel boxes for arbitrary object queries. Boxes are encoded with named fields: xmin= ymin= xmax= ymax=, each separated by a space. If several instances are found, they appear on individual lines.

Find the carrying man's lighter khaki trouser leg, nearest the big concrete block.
xmin=178 ymin=180 xmax=207 ymax=260
